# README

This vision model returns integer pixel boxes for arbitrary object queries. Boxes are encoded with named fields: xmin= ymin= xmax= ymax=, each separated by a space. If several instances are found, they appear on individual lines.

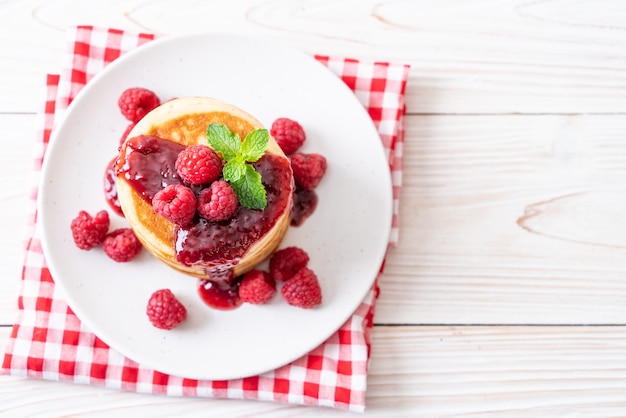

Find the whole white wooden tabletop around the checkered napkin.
xmin=0 ymin=0 xmax=626 ymax=417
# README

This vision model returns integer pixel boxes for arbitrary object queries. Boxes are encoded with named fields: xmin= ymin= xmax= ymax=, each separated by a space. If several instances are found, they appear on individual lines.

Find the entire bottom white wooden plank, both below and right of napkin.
xmin=0 ymin=327 xmax=626 ymax=417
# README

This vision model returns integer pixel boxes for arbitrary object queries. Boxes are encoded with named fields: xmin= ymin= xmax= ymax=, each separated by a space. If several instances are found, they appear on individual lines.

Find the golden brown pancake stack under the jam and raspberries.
xmin=117 ymin=97 xmax=293 ymax=278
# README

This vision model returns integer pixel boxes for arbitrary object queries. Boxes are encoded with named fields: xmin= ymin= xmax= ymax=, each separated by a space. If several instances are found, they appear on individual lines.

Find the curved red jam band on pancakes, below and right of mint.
xmin=176 ymin=153 xmax=292 ymax=266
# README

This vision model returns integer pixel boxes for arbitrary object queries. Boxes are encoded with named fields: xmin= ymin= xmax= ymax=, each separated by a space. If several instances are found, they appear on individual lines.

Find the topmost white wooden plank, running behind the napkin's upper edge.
xmin=0 ymin=0 xmax=626 ymax=113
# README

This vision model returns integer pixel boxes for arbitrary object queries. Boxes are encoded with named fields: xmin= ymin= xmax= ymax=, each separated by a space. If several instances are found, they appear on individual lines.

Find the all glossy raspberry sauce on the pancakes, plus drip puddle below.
xmin=117 ymin=136 xmax=294 ymax=309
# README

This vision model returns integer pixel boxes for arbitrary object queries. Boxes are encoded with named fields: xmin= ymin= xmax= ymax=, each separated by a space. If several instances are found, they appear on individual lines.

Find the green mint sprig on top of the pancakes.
xmin=207 ymin=123 xmax=269 ymax=209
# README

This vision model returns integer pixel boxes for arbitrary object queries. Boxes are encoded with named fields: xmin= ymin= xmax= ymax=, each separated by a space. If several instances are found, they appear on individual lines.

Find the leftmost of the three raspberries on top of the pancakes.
xmin=152 ymin=184 xmax=196 ymax=226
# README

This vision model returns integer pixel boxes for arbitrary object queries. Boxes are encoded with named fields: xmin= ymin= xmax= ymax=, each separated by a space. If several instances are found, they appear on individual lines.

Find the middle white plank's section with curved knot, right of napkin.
xmin=375 ymin=115 xmax=626 ymax=324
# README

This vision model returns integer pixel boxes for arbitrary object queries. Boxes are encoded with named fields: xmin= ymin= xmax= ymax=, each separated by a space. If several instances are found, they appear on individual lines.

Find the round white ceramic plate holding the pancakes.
xmin=40 ymin=34 xmax=392 ymax=379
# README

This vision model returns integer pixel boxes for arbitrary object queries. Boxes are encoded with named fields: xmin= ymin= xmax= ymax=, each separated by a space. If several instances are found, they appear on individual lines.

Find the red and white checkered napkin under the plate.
xmin=2 ymin=26 xmax=408 ymax=411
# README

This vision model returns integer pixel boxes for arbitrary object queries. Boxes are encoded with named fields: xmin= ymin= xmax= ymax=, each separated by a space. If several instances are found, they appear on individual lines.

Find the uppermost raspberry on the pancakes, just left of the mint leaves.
xmin=176 ymin=145 xmax=223 ymax=185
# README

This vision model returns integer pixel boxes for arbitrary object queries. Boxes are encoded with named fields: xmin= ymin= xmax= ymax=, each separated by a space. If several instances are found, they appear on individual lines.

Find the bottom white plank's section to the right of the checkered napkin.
xmin=368 ymin=327 xmax=626 ymax=416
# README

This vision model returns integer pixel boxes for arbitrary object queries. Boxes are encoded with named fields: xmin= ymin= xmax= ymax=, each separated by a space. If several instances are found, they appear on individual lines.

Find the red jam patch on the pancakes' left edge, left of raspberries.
xmin=117 ymin=135 xmax=185 ymax=203
